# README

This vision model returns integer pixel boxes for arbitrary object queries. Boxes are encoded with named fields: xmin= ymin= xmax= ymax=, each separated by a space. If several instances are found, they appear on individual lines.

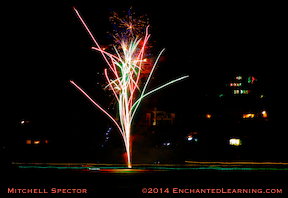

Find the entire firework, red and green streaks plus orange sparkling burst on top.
xmin=70 ymin=8 xmax=188 ymax=168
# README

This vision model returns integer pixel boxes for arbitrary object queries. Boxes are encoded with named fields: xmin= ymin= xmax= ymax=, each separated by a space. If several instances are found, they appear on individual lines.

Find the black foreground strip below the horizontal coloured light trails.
xmin=1 ymin=168 xmax=288 ymax=197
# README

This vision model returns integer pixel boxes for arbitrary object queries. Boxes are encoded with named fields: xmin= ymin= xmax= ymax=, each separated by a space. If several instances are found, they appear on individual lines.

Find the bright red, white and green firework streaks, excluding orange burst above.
xmin=70 ymin=8 xmax=188 ymax=168
